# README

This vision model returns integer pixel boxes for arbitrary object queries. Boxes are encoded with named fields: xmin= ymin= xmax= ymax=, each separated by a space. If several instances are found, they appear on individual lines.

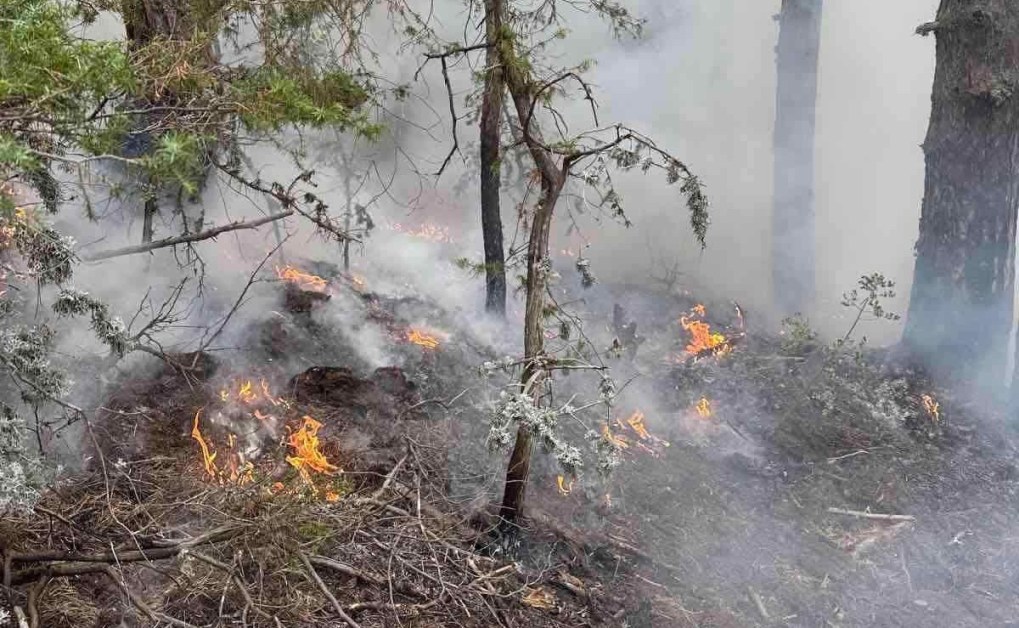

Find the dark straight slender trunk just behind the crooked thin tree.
xmin=480 ymin=0 xmax=506 ymax=316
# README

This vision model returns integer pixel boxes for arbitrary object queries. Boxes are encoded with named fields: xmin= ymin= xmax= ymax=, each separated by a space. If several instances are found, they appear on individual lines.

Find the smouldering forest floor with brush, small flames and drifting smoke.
xmin=0 ymin=268 xmax=1019 ymax=628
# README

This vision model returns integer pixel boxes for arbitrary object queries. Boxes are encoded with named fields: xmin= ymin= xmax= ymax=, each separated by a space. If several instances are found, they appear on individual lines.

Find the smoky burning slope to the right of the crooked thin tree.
xmin=517 ymin=287 xmax=1019 ymax=626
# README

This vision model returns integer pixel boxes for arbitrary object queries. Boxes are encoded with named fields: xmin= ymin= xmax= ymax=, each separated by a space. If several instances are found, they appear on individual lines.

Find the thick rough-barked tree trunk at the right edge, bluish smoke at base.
xmin=903 ymin=0 xmax=1019 ymax=389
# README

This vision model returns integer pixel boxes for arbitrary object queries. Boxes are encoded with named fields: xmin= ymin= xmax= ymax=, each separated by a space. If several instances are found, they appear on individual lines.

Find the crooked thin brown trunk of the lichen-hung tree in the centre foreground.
xmin=498 ymin=31 xmax=567 ymax=524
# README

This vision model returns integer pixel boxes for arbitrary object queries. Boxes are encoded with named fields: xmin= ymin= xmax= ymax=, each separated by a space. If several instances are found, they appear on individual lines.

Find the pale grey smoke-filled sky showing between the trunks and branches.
xmin=61 ymin=0 xmax=936 ymax=348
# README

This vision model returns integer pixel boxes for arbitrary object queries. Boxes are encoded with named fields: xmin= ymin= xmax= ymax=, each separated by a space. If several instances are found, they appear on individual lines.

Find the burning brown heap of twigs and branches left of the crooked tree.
xmin=0 ymin=352 xmax=603 ymax=628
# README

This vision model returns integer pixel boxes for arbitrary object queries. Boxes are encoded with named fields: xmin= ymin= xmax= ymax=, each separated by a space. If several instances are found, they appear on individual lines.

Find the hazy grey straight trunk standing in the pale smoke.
xmin=771 ymin=0 xmax=821 ymax=315
